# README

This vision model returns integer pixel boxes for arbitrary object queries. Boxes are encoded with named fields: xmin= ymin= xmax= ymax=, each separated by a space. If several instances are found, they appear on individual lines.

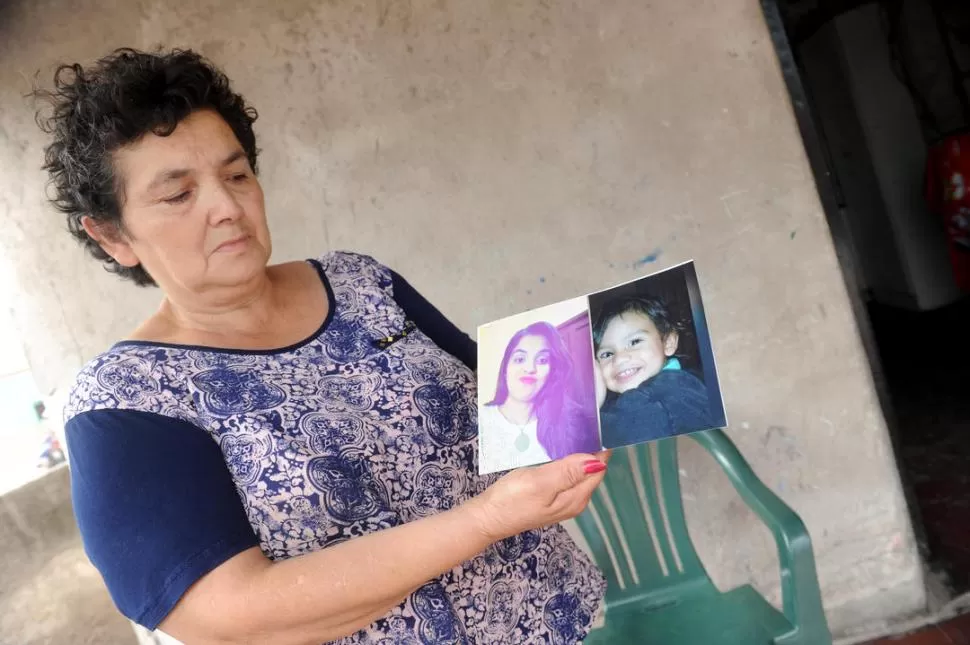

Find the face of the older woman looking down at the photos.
xmin=89 ymin=110 xmax=272 ymax=295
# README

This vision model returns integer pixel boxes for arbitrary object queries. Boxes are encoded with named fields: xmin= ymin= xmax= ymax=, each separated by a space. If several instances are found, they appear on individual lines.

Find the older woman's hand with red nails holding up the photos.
xmin=468 ymin=451 xmax=610 ymax=542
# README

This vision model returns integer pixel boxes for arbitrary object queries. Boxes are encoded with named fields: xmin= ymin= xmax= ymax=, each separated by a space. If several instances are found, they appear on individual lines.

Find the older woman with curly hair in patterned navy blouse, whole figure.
xmin=37 ymin=50 xmax=606 ymax=644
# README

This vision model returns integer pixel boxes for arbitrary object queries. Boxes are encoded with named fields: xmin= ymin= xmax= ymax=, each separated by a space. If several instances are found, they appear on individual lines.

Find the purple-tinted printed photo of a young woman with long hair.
xmin=478 ymin=297 xmax=600 ymax=474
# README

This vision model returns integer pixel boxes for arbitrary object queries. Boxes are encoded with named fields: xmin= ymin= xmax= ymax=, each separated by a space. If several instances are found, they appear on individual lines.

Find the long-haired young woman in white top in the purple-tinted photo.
xmin=479 ymin=322 xmax=600 ymax=472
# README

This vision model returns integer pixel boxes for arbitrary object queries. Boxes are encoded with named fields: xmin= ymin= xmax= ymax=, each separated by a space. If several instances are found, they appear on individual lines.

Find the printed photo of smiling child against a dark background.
xmin=589 ymin=262 xmax=727 ymax=448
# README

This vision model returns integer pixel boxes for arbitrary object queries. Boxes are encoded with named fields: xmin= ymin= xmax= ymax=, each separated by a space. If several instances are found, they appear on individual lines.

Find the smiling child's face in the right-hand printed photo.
xmin=596 ymin=311 xmax=678 ymax=394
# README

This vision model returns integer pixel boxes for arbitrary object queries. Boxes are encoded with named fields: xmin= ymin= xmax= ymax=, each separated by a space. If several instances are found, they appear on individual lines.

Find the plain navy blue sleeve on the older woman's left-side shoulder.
xmin=66 ymin=410 xmax=259 ymax=629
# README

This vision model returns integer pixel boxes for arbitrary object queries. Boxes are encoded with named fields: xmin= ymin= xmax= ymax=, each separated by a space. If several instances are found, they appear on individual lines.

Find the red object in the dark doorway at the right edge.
xmin=926 ymin=134 xmax=970 ymax=292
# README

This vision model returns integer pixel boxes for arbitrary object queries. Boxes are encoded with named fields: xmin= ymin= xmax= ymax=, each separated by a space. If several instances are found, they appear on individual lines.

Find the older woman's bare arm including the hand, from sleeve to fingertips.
xmin=160 ymin=455 xmax=606 ymax=645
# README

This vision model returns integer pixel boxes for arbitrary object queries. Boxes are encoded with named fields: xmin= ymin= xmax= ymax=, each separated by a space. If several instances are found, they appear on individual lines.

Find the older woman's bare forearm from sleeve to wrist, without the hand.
xmin=159 ymin=498 xmax=491 ymax=645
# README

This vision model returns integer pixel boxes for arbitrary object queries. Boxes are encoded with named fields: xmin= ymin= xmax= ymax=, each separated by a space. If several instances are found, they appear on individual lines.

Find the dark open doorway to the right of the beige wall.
xmin=762 ymin=0 xmax=970 ymax=595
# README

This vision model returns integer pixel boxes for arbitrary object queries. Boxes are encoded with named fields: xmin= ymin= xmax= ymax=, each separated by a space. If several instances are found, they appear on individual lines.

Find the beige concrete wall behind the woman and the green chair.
xmin=0 ymin=0 xmax=924 ymax=631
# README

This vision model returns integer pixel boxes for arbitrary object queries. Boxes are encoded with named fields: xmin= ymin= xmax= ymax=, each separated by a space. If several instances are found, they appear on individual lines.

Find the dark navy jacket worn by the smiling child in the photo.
xmin=600 ymin=370 xmax=714 ymax=448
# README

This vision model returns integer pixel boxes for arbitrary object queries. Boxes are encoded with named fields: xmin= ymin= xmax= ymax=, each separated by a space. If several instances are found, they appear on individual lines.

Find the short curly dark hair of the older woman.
xmin=33 ymin=48 xmax=258 ymax=286
